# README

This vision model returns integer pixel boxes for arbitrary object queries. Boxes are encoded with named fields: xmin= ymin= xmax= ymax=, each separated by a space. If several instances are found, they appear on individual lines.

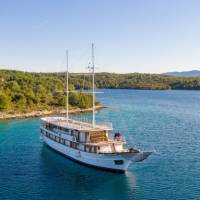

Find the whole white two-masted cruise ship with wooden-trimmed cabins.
xmin=41 ymin=44 xmax=152 ymax=173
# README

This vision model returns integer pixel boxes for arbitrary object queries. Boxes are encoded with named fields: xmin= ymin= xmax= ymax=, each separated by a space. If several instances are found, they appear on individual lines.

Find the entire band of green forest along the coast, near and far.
xmin=0 ymin=70 xmax=200 ymax=113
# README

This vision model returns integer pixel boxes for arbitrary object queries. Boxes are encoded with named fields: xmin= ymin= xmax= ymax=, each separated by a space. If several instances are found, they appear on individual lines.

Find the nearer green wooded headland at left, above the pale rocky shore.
xmin=0 ymin=70 xmax=96 ymax=112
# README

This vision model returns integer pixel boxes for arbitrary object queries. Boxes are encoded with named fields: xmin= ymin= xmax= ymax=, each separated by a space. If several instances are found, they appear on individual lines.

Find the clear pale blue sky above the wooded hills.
xmin=0 ymin=0 xmax=200 ymax=73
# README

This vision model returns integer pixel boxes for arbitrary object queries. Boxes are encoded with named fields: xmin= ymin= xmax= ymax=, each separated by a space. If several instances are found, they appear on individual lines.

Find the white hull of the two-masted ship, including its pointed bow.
xmin=42 ymin=135 xmax=151 ymax=172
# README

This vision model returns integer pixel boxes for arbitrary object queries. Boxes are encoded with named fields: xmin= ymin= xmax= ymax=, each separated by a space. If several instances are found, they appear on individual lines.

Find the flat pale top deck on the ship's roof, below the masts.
xmin=41 ymin=117 xmax=113 ymax=131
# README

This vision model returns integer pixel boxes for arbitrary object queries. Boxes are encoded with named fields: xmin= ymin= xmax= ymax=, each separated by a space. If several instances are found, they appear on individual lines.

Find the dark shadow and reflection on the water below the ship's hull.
xmin=41 ymin=145 xmax=137 ymax=199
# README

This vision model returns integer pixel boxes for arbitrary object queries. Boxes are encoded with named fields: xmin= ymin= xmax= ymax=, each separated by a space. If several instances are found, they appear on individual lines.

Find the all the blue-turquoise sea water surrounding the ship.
xmin=0 ymin=90 xmax=200 ymax=200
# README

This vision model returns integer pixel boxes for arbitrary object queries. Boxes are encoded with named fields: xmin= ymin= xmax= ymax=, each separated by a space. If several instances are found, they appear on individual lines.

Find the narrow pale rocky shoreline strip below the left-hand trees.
xmin=0 ymin=106 xmax=106 ymax=120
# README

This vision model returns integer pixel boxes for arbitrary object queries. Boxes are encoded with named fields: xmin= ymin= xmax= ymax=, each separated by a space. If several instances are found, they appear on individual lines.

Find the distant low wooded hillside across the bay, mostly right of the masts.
xmin=71 ymin=73 xmax=200 ymax=90
